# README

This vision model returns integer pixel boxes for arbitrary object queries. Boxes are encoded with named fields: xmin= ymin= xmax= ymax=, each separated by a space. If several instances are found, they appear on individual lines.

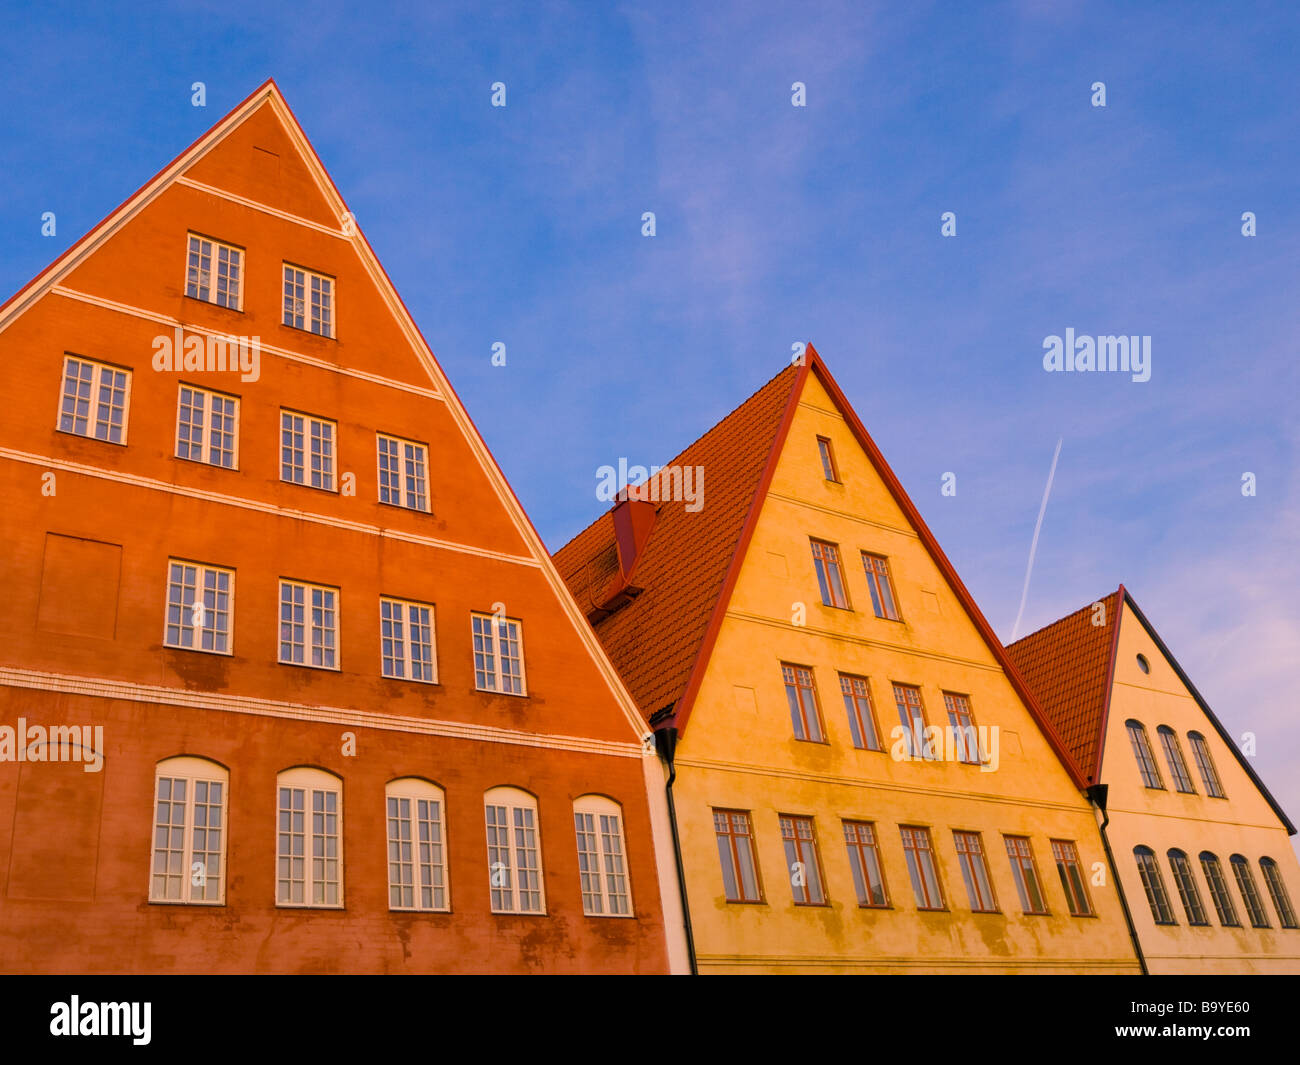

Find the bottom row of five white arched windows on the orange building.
xmin=150 ymin=757 xmax=632 ymax=917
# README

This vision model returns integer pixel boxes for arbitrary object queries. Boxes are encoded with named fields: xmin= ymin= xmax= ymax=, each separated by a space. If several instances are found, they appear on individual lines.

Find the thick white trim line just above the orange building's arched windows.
xmin=0 ymin=666 xmax=642 ymax=758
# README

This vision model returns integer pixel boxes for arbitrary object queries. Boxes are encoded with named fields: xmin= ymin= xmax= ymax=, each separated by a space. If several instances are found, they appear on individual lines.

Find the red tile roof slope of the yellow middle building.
xmin=555 ymin=365 xmax=801 ymax=717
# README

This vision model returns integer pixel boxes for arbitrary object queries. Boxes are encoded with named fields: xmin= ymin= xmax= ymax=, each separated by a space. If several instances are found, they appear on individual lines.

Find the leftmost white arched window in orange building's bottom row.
xmin=150 ymin=757 xmax=230 ymax=905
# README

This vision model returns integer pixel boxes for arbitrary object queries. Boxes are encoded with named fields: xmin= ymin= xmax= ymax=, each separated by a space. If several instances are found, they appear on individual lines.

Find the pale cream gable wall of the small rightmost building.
xmin=1101 ymin=605 xmax=1300 ymax=973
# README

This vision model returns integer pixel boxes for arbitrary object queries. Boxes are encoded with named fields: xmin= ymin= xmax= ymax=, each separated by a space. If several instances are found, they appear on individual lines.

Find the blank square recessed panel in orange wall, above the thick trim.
xmin=36 ymin=533 xmax=122 ymax=640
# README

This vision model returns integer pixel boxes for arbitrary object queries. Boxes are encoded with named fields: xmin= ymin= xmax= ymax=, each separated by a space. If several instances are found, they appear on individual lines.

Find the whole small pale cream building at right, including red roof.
xmin=1008 ymin=585 xmax=1300 ymax=973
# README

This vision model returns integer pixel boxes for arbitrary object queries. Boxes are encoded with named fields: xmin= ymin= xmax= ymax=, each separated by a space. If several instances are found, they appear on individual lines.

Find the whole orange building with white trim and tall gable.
xmin=0 ymin=82 xmax=684 ymax=973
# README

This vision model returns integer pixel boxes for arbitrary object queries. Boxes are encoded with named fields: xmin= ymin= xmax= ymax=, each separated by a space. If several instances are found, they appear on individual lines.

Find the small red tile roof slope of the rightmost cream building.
xmin=1006 ymin=590 xmax=1119 ymax=784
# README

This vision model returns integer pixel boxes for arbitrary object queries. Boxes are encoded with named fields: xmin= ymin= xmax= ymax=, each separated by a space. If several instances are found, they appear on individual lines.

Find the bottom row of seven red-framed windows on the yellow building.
xmin=712 ymin=809 xmax=1095 ymax=917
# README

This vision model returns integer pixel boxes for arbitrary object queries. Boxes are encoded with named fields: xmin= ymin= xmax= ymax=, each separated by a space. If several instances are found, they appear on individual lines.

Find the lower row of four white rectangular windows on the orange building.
xmin=163 ymin=559 xmax=527 ymax=696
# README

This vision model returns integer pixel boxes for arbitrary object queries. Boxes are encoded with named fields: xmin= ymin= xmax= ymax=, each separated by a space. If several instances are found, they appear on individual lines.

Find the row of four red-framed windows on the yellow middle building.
xmin=781 ymin=662 xmax=988 ymax=766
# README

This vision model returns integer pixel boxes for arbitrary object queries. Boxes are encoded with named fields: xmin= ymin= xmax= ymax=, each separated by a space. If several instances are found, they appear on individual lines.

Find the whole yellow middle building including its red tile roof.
xmin=556 ymin=347 xmax=1139 ymax=973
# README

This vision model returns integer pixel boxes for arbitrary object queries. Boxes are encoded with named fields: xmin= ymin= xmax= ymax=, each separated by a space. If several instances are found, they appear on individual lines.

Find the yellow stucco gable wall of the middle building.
xmin=676 ymin=375 xmax=1138 ymax=973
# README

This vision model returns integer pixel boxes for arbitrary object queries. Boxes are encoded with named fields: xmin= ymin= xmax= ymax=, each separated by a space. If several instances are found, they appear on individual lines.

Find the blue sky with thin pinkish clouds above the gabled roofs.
xmin=0 ymin=0 xmax=1300 ymax=842
